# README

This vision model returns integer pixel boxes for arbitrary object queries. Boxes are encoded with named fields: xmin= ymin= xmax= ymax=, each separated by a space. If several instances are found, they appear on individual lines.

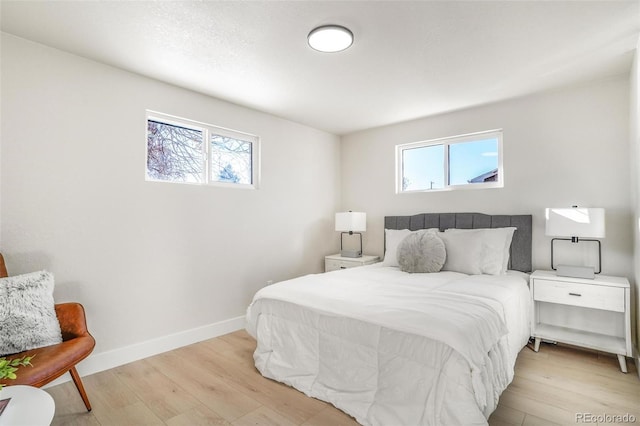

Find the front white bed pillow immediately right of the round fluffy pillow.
xmin=438 ymin=232 xmax=482 ymax=275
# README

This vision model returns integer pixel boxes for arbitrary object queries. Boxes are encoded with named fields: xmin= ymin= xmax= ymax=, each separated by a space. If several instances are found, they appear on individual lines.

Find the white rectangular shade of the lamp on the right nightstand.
xmin=545 ymin=207 xmax=606 ymax=238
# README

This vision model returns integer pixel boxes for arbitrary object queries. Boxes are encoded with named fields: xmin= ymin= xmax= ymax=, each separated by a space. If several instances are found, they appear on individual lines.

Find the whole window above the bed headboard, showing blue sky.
xmin=396 ymin=130 xmax=504 ymax=193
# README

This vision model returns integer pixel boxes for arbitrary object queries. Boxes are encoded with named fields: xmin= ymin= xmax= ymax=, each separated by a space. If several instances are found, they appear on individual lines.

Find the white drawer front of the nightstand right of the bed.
xmin=533 ymin=279 xmax=625 ymax=312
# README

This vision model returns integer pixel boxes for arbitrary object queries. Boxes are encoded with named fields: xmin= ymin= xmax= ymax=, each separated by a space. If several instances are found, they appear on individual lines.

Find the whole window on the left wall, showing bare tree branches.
xmin=146 ymin=112 xmax=258 ymax=188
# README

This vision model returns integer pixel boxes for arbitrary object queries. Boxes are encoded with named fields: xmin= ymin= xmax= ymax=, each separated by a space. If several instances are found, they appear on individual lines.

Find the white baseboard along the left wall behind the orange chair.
xmin=44 ymin=316 xmax=245 ymax=388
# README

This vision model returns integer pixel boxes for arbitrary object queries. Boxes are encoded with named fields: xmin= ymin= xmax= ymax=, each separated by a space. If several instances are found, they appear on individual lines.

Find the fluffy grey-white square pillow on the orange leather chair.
xmin=0 ymin=271 xmax=62 ymax=356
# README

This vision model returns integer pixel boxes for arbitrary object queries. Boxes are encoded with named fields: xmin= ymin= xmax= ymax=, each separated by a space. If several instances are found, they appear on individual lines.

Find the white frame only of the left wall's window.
xmin=144 ymin=110 xmax=260 ymax=189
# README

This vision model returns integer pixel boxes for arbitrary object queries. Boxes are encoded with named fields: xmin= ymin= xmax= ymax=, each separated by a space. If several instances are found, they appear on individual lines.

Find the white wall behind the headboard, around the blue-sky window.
xmin=342 ymin=76 xmax=633 ymax=277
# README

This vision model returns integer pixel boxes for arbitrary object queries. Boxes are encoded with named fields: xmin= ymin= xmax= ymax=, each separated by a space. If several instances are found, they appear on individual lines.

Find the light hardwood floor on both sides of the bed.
xmin=46 ymin=331 xmax=640 ymax=426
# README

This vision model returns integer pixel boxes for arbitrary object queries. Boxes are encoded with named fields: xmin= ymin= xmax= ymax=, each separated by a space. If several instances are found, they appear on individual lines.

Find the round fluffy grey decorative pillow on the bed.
xmin=397 ymin=231 xmax=447 ymax=273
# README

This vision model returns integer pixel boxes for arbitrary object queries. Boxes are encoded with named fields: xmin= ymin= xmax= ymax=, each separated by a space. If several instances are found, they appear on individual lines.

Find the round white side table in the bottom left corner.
xmin=0 ymin=385 xmax=56 ymax=426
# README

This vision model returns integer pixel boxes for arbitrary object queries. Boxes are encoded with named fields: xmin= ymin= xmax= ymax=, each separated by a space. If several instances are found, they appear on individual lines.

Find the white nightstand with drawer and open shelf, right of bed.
xmin=529 ymin=271 xmax=631 ymax=373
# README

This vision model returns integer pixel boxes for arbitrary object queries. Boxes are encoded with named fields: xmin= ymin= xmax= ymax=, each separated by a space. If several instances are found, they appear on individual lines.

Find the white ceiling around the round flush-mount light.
xmin=0 ymin=0 xmax=640 ymax=135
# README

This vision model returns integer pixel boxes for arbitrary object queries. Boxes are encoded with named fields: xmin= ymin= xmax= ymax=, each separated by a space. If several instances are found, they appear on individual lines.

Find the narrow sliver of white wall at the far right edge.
xmin=629 ymin=39 xmax=640 ymax=362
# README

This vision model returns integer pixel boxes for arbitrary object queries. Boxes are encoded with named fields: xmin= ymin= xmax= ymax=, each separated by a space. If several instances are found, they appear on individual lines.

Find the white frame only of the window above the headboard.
xmin=396 ymin=129 xmax=504 ymax=194
